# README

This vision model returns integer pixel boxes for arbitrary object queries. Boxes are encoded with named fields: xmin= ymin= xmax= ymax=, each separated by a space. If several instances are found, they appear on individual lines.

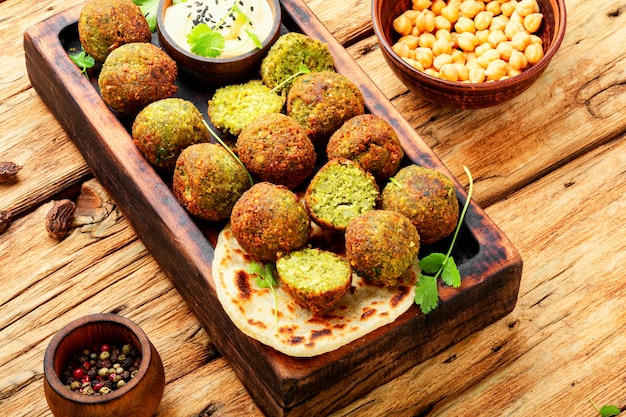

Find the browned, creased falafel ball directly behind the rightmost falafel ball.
xmin=326 ymin=114 xmax=404 ymax=184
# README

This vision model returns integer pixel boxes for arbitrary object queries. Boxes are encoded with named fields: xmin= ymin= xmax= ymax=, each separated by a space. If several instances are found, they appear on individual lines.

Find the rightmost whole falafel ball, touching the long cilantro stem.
xmin=382 ymin=165 xmax=459 ymax=244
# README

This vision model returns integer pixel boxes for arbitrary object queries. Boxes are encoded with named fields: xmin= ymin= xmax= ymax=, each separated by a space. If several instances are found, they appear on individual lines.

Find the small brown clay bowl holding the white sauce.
xmin=157 ymin=0 xmax=281 ymax=86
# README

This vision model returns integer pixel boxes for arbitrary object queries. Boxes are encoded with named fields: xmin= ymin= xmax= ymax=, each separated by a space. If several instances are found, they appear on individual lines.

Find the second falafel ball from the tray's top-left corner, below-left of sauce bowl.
xmin=98 ymin=42 xmax=178 ymax=115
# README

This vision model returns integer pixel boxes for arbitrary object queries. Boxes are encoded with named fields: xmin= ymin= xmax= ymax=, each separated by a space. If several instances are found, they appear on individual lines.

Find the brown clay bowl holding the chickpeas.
xmin=372 ymin=0 xmax=566 ymax=109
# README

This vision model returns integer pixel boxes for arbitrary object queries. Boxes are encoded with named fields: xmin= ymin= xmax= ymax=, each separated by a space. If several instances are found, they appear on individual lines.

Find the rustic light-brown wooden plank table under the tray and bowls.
xmin=0 ymin=0 xmax=626 ymax=417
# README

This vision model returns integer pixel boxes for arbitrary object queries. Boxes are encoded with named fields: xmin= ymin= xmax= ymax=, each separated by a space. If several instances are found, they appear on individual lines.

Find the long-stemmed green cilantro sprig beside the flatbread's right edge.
xmin=415 ymin=167 xmax=474 ymax=314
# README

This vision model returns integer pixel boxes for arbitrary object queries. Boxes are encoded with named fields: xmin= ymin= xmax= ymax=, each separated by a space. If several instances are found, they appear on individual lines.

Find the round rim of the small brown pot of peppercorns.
xmin=44 ymin=313 xmax=153 ymax=405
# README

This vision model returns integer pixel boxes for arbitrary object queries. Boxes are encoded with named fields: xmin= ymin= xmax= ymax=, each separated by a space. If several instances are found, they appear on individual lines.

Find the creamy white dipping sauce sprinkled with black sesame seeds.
xmin=163 ymin=0 xmax=274 ymax=58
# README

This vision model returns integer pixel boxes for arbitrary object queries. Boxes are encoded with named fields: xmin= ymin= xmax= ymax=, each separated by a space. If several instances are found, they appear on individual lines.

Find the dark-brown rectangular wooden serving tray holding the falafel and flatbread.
xmin=24 ymin=0 xmax=522 ymax=416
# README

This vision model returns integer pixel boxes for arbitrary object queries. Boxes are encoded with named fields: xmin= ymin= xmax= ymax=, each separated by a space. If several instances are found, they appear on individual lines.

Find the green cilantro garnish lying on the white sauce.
xmin=187 ymin=4 xmax=263 ymax=58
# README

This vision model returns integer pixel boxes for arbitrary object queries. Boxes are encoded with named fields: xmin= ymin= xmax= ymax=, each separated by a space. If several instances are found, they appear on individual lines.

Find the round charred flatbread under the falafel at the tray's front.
xmin=213 ymin=224 xmax=418 ymax=357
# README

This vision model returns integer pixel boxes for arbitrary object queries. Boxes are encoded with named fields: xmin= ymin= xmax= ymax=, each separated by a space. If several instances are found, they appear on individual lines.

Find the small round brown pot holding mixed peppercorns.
xmin=44 ymin=314 xmax=165 ymax=417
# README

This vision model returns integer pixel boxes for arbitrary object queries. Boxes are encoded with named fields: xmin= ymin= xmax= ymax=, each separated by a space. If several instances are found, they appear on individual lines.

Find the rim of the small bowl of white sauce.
xmin=157 ymin=0 xmax=282 ymax=64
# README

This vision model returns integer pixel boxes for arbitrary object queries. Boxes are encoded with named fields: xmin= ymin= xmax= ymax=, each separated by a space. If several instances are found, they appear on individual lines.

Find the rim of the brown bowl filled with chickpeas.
xmin=371 ymin=0 xmax=567 ymax=91
